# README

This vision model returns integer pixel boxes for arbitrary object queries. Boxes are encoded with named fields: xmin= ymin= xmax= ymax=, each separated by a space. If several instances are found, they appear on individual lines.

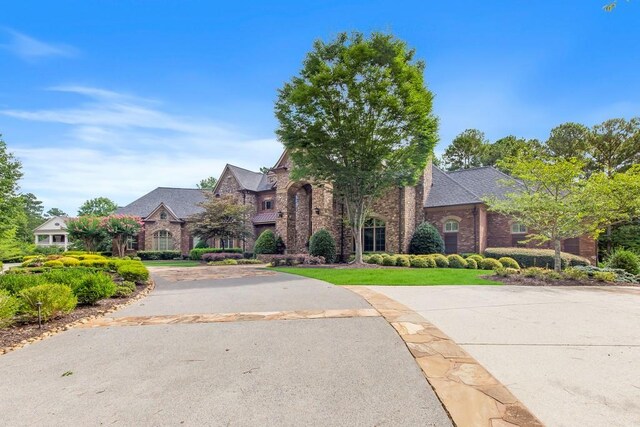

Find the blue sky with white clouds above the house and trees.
xmin=0 ymin=0 xmax=640 ymax=214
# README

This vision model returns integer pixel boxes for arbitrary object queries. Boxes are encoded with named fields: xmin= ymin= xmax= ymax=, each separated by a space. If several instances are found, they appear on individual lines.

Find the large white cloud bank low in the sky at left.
xmin=0 ymin=86 xmax=282 ymax=214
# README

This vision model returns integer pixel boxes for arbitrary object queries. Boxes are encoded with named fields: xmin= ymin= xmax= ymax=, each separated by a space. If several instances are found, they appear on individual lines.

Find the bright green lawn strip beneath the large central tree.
xmin=273 ymin=267 xmax=502 ymax=286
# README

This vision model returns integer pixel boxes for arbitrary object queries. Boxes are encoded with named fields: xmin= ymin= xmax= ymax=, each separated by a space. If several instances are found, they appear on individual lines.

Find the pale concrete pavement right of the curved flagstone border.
xmin=371 ymin=286 xmax=640 ymax=426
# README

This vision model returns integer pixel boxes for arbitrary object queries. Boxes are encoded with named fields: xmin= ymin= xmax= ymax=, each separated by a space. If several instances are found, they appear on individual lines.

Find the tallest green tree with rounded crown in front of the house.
xmin=275 ymin=33 xmax=438 ymax=263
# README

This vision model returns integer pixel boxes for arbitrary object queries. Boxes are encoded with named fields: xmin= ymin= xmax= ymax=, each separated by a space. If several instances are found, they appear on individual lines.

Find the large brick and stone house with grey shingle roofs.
xmin=118 ymin=152 xmax=596 ymax=261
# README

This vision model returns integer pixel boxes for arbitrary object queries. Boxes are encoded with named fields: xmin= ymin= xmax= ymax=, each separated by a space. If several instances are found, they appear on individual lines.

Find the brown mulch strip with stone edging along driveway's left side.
xmin=0 ymin=285 xmax=153 ymax=355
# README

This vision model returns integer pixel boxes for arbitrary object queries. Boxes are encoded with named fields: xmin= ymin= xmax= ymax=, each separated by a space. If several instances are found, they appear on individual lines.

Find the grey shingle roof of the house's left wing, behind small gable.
xmin=117 ymin=187 xmax=205 ymax=219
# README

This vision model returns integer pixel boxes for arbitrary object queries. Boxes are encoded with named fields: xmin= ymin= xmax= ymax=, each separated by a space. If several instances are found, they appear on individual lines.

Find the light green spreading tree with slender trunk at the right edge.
xmin=486 ymin=157 xmax=640 ymax=271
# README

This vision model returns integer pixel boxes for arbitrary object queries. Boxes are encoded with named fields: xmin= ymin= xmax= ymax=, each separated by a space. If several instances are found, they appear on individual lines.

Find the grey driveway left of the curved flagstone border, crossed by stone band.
xmin=0 ymin=267 xmax=451 ymax=426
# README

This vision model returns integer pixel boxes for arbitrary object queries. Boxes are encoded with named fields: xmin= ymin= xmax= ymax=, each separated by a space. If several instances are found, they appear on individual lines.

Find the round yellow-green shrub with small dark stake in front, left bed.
xmin=20 ymin=283 xmax=78 ymax=322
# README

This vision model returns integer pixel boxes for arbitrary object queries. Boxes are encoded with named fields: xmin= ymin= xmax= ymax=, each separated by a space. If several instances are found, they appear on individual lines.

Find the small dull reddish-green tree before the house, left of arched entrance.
xmin=189 ymin=194 xmax=252 ymax=247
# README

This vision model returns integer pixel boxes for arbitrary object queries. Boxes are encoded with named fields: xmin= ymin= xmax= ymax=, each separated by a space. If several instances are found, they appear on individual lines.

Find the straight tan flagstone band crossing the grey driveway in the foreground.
xmin=79 ymin=308 xmax=380 ymax=328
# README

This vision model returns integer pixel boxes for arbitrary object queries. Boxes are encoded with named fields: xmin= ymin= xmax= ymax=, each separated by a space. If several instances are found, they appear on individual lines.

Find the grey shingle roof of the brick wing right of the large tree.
xmin=425 ymin=166 xmax=513 ymax=208
